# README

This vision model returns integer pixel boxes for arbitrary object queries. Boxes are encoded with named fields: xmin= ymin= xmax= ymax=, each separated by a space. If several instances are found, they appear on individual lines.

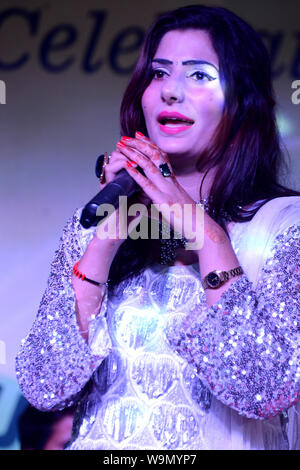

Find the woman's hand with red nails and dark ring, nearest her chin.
xmin=117 ymin=134 xmax=200 ymax=241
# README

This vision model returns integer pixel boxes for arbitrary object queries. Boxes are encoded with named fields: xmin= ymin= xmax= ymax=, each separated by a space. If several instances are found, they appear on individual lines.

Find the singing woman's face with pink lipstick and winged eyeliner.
xmin=142 ymin=29 xmax=224 ymax=164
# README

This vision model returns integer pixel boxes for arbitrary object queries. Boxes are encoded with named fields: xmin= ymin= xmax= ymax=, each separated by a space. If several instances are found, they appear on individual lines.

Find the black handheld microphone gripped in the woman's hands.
xmin=80 ymin=170 xmax=141 ymax=228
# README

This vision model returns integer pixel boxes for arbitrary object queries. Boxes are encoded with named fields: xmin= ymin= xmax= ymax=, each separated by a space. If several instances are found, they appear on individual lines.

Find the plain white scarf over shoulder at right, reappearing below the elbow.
xmin=205 ymin=196 xmax=300 ymax=450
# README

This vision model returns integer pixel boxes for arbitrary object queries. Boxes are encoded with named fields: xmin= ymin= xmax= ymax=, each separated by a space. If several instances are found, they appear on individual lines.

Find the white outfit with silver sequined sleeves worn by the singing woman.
xmin=16 ymin=197 xmax=300 ymax=450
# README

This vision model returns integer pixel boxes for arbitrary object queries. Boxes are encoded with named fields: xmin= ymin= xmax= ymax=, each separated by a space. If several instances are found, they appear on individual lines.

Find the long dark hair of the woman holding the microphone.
xmin=110 ymin=5 xmax=300 ymax=286
